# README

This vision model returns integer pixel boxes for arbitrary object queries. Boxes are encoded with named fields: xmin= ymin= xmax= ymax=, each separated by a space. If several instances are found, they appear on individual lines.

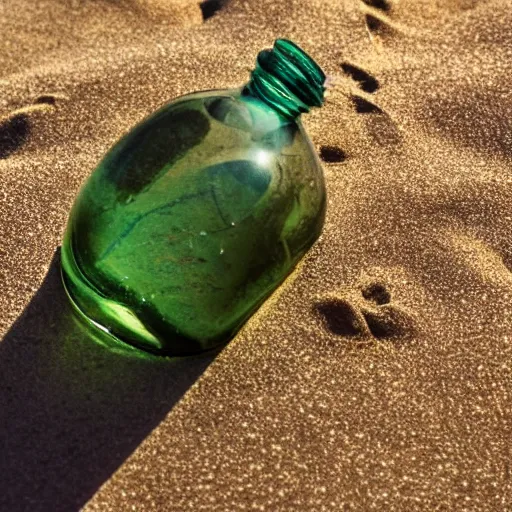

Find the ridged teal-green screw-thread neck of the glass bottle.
xmin=242 ymin=39 xmax=325 ymax=119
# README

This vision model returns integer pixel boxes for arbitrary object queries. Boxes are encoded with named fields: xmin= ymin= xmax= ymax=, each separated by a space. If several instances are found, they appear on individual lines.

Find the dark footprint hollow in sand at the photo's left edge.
xmin=0 ymin=94 xmax=63 ymax=160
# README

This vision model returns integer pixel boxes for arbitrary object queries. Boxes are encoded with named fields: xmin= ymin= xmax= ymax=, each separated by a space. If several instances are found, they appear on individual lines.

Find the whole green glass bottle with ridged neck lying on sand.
xmin=62 ymin=39 xmax=326 ymax=355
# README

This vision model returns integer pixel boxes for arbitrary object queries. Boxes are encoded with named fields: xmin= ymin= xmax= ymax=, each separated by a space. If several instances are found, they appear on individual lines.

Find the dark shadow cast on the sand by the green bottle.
xmin=0 ymin=251 xmax=219 ymax=512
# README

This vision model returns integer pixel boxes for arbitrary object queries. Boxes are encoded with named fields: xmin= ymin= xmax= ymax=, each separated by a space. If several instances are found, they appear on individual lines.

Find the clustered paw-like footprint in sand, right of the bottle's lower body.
xmin=314 ymin=281 xmax=417 ymax=341
